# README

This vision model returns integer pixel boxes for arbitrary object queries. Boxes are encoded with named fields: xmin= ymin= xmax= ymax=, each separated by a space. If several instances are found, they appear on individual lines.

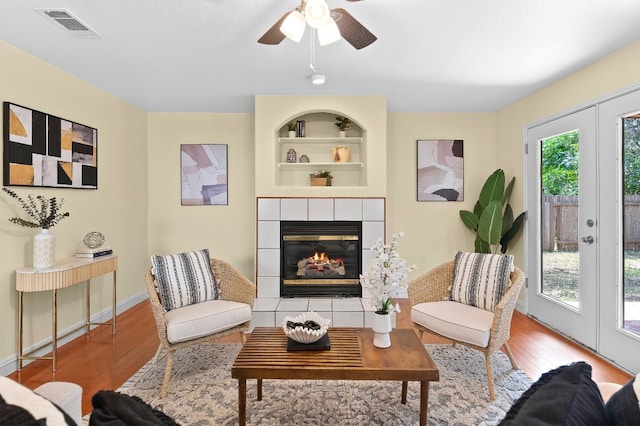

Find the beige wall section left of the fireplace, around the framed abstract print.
xmin=148 ymin=113 xmax=256 ymax=281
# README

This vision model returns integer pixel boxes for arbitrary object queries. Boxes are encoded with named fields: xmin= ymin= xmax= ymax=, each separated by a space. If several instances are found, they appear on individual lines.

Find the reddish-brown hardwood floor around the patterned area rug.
xmin=9 ymin=300 xmax=631 ymax=414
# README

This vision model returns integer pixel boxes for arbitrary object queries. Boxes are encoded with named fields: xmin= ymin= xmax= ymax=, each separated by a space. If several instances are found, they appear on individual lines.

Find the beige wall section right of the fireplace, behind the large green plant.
xmin=387 ymin=113 xmax=502 ymax=276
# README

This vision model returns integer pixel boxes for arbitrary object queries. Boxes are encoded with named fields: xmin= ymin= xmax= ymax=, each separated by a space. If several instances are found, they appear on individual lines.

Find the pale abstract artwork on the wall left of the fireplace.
xmin=180 ymin=144 xmax=229 ymax=206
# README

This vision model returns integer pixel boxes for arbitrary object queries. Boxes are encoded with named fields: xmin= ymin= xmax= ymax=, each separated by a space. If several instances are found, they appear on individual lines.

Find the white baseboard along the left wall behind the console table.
xmin=0 ymin=290 xmax=148 ymax=376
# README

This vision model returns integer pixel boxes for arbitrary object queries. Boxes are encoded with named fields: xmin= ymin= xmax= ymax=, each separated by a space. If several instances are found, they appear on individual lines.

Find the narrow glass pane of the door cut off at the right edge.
xmin=622 ymin=114 xmax=640 ymax=336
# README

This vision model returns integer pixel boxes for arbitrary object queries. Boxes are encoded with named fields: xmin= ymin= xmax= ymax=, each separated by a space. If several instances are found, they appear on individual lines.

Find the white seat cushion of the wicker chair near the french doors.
xmin=411 ymin=301 xmax=494 ymax=348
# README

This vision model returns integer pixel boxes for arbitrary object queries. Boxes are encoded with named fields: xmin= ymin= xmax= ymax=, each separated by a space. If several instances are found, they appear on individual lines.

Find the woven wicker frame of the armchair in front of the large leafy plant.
xmin=407 ymin=261 xmax=524 ymax=400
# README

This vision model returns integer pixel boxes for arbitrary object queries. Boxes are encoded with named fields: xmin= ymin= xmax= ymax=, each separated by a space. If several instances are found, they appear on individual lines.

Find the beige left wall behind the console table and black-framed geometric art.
xmin=0 ymin=41 xmax=148 ymax=363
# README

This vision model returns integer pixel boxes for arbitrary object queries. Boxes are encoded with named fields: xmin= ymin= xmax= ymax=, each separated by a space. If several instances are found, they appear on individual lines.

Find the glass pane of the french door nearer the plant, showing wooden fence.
xmin=540 ymin=130 xmax=580 ymax=309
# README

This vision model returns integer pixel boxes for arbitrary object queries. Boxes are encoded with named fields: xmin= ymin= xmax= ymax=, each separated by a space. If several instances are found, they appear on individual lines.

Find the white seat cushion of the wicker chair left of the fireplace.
xmin=164 ymin=300 xmax=251 ymax=343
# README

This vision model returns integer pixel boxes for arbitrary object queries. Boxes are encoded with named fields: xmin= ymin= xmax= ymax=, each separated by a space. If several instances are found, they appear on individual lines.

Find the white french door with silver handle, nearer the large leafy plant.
xmin=526 ymin=107 xmax=599 ymax=349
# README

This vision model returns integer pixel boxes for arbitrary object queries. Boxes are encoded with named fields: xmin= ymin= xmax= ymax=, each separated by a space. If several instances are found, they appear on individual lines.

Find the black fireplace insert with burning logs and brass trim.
xmin=280 ymin=221 xmax=362 ymax=297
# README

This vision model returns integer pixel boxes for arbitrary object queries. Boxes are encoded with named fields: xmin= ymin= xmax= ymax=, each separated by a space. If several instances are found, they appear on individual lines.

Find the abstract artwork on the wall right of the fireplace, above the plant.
xmin=417 ymin=139 xmax=464 ymax=201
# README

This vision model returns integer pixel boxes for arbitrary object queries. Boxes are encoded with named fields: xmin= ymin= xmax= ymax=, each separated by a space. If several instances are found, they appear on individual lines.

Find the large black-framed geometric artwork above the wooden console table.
xmin=2 ymin=102 xmax=98 ymax=189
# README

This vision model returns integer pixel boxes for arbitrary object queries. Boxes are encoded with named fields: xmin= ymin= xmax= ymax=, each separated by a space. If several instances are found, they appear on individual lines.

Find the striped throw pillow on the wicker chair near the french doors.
xmin=451 ymin=251 xmax=513 ymax=312
